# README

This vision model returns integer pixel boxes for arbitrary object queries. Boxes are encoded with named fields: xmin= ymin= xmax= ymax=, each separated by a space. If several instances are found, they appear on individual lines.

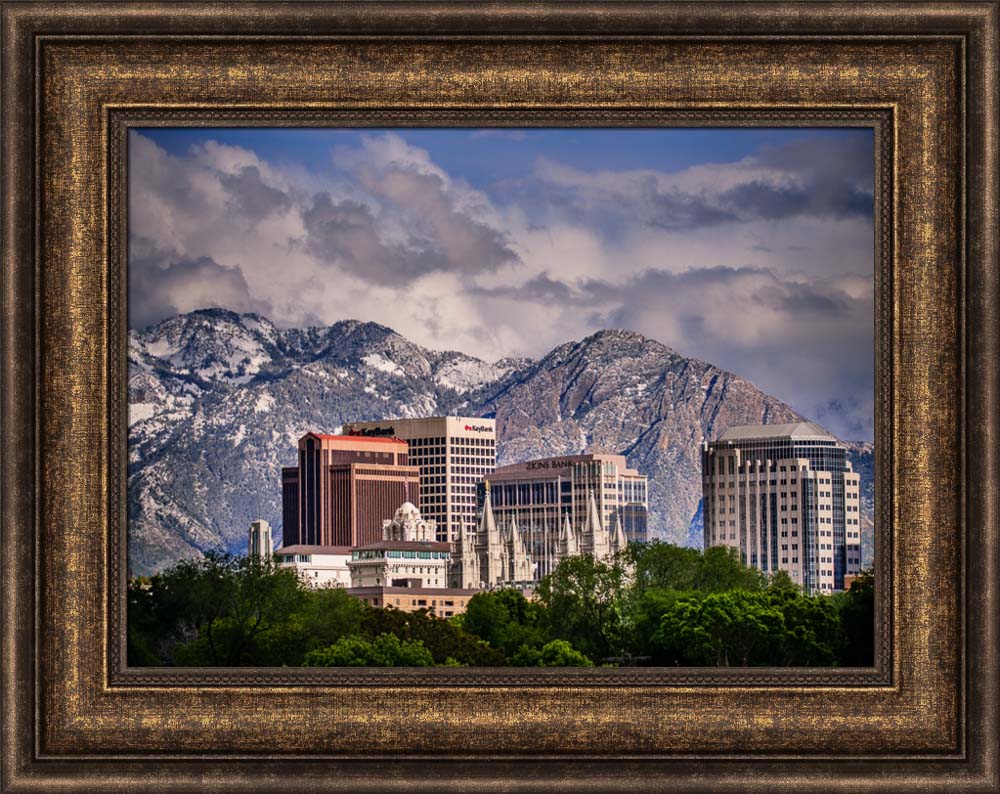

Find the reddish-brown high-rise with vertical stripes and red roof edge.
xmin=281 ymin=433 xmax=420 ymax=546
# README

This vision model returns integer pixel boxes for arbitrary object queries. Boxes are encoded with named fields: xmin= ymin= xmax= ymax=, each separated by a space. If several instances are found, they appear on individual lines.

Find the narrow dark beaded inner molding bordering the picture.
xmin=105 ymin=106 xmax=896 ymax=687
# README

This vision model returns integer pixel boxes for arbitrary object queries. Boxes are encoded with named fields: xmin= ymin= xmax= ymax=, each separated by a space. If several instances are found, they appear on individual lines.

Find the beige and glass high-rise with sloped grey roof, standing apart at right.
xmin=702 ymin=422 xmax=861 ymax=593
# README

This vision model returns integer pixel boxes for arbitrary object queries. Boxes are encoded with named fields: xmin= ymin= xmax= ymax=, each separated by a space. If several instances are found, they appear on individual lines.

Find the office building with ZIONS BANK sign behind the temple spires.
xmin=479 ymin=453 xmax=649 ymax=578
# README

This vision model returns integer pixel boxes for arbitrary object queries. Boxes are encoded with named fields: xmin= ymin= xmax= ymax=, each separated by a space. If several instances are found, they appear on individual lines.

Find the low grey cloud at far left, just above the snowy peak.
xmin=128 ymin=240 xmax=272 ymax=328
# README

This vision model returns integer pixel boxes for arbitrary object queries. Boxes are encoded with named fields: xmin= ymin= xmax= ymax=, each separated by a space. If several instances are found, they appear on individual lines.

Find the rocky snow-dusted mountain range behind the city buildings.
xmin=129 ymin=309 xmax=871 ymax=574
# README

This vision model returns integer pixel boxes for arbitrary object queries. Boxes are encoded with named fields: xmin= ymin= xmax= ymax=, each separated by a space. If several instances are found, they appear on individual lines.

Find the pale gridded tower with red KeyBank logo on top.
xmin=343 ymin=416 xmax=497 ymax=541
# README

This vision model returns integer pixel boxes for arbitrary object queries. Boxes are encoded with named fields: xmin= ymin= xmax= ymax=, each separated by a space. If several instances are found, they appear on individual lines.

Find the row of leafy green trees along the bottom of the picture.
xmin=128 ymin=542 xmax=874 ymax=667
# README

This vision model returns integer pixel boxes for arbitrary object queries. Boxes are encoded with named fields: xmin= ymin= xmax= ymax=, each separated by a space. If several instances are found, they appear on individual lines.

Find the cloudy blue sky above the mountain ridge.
xmin=129 ymin=129 xmax=874 ymax=439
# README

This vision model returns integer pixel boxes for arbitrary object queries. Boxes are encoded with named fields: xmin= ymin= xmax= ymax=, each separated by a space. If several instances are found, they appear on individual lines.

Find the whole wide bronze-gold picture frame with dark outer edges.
xmin=2 ymin=1 xmax=1000 ymax=792
